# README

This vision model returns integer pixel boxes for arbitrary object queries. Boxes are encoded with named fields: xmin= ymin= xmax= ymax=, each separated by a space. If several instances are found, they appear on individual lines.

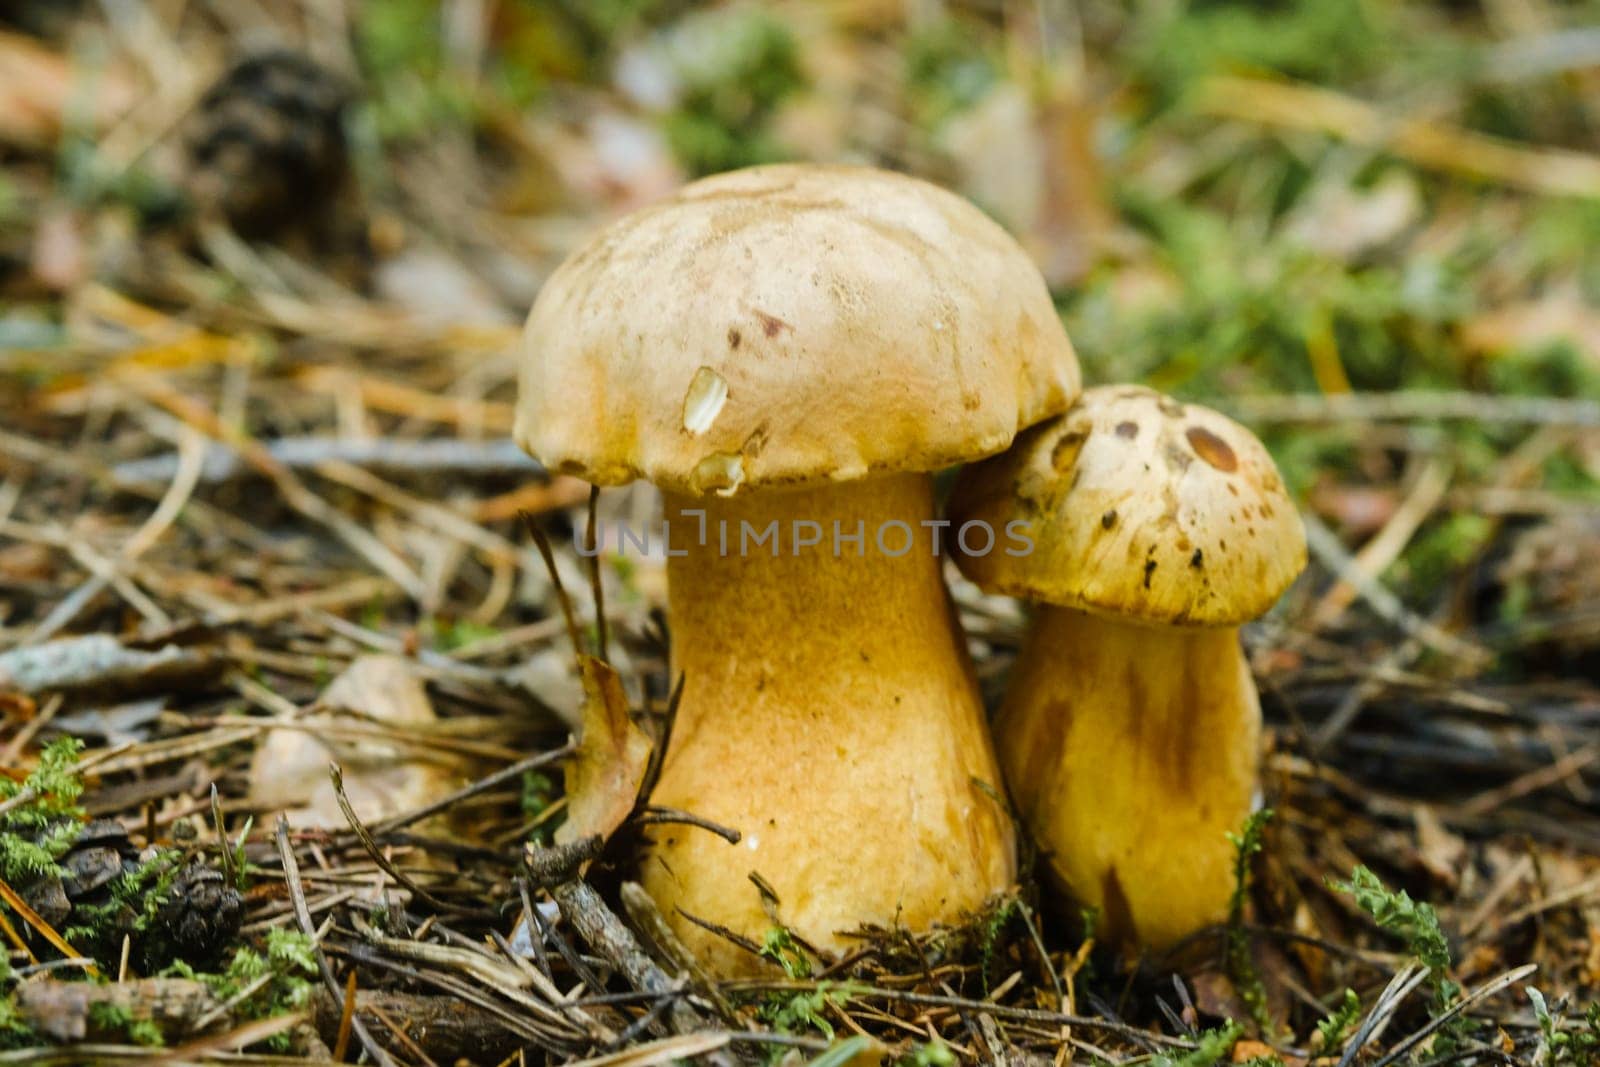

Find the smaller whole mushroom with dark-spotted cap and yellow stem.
xmin=950 ymin=386 xmax=1306 ymax=950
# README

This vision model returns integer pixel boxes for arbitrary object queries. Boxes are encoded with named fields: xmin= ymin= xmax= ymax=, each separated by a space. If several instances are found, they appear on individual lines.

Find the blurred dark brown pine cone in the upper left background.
xmin=189 ymin=51 xmax=350 ymax=237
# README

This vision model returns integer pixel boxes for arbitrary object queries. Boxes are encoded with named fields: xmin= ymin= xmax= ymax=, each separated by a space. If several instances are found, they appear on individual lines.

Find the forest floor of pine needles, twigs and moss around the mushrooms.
xmin=0 ymin=0 xmax=1600 ymax=1067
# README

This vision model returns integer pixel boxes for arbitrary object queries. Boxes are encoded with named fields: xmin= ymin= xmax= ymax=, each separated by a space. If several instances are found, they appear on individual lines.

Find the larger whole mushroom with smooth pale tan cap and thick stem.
xmin=517 ymin=165 xmax=1078 ymax=973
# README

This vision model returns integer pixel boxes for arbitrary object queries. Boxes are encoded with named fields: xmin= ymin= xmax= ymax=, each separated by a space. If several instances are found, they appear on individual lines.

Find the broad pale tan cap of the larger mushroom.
xmin=515 ymin=165 xmax=1080 ymax=494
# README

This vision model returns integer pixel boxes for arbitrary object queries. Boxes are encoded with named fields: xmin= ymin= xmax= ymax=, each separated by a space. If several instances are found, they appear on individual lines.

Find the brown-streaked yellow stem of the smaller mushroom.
xmin=995 ymin=606 xmax=1261 ymax=950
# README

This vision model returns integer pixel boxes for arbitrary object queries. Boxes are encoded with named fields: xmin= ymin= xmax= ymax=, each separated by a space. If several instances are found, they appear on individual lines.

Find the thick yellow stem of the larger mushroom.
xmin=643 ymin=475 xmax=1014 ymax=973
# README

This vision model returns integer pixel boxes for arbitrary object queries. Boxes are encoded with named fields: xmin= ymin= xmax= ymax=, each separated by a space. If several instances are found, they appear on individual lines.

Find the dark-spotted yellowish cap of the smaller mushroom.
xmin=949 ymin=386 xmax=1306 ymax=625
